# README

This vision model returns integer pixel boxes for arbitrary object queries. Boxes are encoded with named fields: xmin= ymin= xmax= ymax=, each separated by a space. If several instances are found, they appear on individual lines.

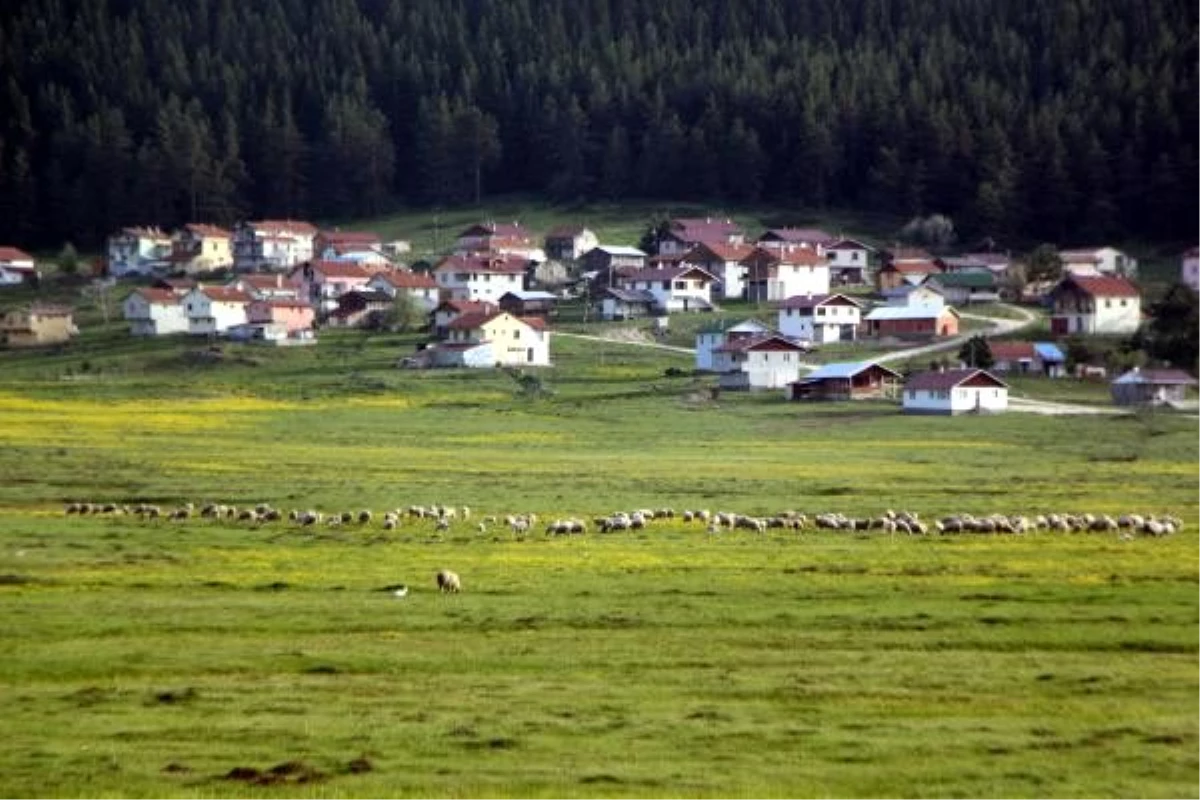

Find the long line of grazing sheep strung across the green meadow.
xmin=65 ymin=503 xmax=1183 ymax=537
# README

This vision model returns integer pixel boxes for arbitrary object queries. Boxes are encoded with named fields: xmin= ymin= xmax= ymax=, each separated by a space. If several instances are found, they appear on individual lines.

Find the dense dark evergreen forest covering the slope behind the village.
xmin=0 ymin=0 xmax=1200 ymax=245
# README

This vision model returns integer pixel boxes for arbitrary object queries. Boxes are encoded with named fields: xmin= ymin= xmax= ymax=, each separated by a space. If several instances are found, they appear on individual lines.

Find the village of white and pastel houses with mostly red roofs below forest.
xmin=0 ymin=217 xmax=1200 ymax=414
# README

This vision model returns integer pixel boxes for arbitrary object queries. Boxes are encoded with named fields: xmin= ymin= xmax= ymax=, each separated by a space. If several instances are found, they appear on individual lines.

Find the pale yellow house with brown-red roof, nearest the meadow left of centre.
xmin=434 ymin=311 xmax=550 ymax=367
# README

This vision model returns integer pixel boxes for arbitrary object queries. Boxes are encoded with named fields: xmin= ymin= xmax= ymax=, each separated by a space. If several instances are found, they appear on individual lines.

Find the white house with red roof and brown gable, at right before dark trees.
xmin=1049 ymin=275 xmax=1141 ymax=336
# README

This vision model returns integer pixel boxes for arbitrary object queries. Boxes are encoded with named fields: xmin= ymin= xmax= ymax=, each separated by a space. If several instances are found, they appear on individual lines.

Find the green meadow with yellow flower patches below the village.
xmin=0 ymin=316 xmax=1200 ymax=798
